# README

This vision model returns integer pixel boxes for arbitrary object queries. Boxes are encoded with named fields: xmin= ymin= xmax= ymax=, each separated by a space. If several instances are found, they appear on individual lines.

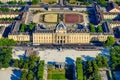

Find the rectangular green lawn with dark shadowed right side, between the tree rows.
xmin=47 ymin=65 xmax=74 ymax=80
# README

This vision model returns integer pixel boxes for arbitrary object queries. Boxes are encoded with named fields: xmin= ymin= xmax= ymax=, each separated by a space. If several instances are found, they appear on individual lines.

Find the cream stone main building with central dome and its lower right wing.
xmin=33 ymin=22 xmax=113 ymax=45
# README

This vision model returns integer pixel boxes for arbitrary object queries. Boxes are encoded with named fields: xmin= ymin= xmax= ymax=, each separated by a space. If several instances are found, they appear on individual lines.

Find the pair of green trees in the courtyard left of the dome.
xmin=20 ymin=23 xmax=35 ymax=32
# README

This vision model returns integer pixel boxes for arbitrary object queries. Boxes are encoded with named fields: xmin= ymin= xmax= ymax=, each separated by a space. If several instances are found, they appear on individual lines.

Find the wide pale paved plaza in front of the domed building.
xmin=39 ymin=49 xmax=108 ymax=63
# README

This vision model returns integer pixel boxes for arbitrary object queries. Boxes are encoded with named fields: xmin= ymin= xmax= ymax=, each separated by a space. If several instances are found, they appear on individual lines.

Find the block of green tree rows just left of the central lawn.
xmin=13 ymin=55 xmax=45 ymax=80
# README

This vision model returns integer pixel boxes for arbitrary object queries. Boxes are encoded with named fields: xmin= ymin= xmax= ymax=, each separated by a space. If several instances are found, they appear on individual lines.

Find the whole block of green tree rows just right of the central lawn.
xmin=76 ymin=56 xmax=108 ymax=80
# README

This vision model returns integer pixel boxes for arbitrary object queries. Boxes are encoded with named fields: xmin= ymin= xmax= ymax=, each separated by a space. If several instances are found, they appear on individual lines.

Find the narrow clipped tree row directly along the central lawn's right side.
xmin=76 ymin=57 xmax=83 ymax=80
